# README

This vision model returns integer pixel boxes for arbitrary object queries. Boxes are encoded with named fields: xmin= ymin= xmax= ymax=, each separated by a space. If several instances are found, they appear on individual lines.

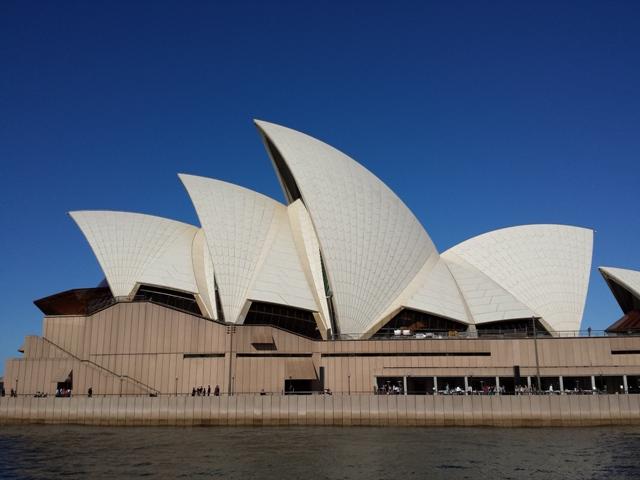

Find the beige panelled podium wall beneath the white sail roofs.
xmin=5 ymin=303 xmax=640 ymax=395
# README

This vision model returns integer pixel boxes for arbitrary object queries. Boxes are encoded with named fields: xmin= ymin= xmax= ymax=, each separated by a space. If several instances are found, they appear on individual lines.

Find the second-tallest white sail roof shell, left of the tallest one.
xmin=179 ymin=174 xmax=318 ymax=323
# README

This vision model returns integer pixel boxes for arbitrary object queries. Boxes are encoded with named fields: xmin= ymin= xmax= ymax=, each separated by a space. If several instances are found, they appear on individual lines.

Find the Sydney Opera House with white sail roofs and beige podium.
xmin=4 ymin=121 xmax=640 ymax=396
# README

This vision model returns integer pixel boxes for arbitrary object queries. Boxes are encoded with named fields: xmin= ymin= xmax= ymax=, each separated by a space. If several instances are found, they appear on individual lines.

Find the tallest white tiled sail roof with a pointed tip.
xmin=256 ymin=121 xmax=438 ymax=335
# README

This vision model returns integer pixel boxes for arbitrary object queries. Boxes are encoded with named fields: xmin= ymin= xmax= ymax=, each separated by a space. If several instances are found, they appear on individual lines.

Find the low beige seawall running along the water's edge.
xmin=0 ymin=395 xmax=640 ymax=427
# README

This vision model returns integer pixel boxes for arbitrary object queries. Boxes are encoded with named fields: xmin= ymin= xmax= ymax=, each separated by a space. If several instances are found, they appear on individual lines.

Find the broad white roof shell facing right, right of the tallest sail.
xmin=442 ymin=225 xmax=593 ymax=332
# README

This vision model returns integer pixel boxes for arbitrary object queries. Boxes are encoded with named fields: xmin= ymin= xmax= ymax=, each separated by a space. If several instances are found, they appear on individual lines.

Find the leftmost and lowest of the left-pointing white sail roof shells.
xmin=69 ymin=210 xmax=198 ymax=297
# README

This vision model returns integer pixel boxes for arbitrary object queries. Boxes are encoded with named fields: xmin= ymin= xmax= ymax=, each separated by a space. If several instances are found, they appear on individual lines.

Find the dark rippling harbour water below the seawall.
xmin=0 ymin=426 xmax=640 ymax=480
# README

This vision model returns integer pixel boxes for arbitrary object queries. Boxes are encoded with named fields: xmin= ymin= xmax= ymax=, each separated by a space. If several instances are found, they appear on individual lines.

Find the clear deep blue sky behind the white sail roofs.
xmin=0 ymin=0 xmax=640 ymax=374
